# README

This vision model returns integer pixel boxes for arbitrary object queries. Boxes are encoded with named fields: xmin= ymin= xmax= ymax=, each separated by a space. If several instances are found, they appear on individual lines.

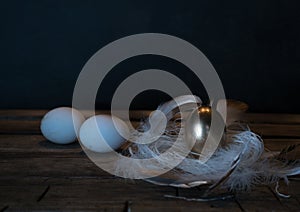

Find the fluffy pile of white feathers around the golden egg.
xmin=115 ymin=98 xmax=300 ymax=190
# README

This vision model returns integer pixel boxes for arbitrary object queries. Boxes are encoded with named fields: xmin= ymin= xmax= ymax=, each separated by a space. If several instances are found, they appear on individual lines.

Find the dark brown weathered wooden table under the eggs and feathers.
xmin=0 ymin=110 xmax=300 ymax=211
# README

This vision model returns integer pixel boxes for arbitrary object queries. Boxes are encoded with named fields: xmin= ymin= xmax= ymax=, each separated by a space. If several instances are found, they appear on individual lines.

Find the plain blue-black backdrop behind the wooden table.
xmin=0 ymin=0 xmax=300 ymax=113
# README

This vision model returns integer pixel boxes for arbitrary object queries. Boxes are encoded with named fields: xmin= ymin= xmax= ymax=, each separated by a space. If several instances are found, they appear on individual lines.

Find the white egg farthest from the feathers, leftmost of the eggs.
xmin=41 ymin=107 xmax=85 ymax=144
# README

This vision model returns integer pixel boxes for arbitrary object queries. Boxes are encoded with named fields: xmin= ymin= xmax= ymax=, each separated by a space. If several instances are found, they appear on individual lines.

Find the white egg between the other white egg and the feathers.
xmin=79 ymin=115 xmax=129 ymax=153
